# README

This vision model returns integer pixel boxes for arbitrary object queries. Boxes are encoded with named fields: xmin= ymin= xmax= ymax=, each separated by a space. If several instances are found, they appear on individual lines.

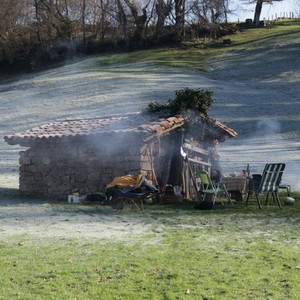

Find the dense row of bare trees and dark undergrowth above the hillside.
xmin=0 ymin=0 xmax=270 ymax=69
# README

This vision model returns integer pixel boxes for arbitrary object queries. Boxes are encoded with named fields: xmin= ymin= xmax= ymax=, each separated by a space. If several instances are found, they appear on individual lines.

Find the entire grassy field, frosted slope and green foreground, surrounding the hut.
xmin=0 ymin=19 xmax=300 ymax=300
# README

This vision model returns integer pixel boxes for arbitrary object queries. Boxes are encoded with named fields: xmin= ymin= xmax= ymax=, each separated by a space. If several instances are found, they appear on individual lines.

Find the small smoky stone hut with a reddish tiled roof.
xmin=4 ymin=113 xmax=237 ymax=199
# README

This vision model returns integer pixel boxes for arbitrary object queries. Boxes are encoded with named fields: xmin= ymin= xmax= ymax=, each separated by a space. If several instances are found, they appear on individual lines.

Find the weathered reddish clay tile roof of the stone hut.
xmin=4 ymin=113 xmax=237 ymax=147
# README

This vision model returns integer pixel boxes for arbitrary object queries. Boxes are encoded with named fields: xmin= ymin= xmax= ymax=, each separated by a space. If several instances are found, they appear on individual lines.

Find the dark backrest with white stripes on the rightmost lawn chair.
xmin=259 ymin=163 xmax=285 ymax=193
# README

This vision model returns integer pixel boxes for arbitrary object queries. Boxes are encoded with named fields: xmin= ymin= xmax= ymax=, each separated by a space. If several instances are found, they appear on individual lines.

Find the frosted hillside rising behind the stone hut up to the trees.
xmin=0 ymin=19 xmax=300 ymax=189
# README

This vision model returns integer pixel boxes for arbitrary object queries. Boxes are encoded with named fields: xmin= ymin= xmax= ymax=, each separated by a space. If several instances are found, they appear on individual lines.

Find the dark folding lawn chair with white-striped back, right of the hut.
xmin=246 ymin=163 xmax=285 ymax=208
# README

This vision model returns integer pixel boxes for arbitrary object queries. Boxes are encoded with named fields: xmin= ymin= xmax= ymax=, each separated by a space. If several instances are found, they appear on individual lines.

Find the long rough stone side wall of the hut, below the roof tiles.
xmin=20 ymin=137 xmax=151 ymax=199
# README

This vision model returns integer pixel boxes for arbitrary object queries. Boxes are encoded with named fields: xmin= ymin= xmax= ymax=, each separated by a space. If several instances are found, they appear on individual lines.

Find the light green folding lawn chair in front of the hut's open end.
xmin=199 ymin=171 xmax=233 ymax=205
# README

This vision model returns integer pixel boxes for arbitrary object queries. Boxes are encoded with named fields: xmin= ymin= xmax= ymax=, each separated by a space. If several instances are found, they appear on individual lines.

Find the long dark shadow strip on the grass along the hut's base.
xmin=0 ymin=188 xmax=300 ymax=218
